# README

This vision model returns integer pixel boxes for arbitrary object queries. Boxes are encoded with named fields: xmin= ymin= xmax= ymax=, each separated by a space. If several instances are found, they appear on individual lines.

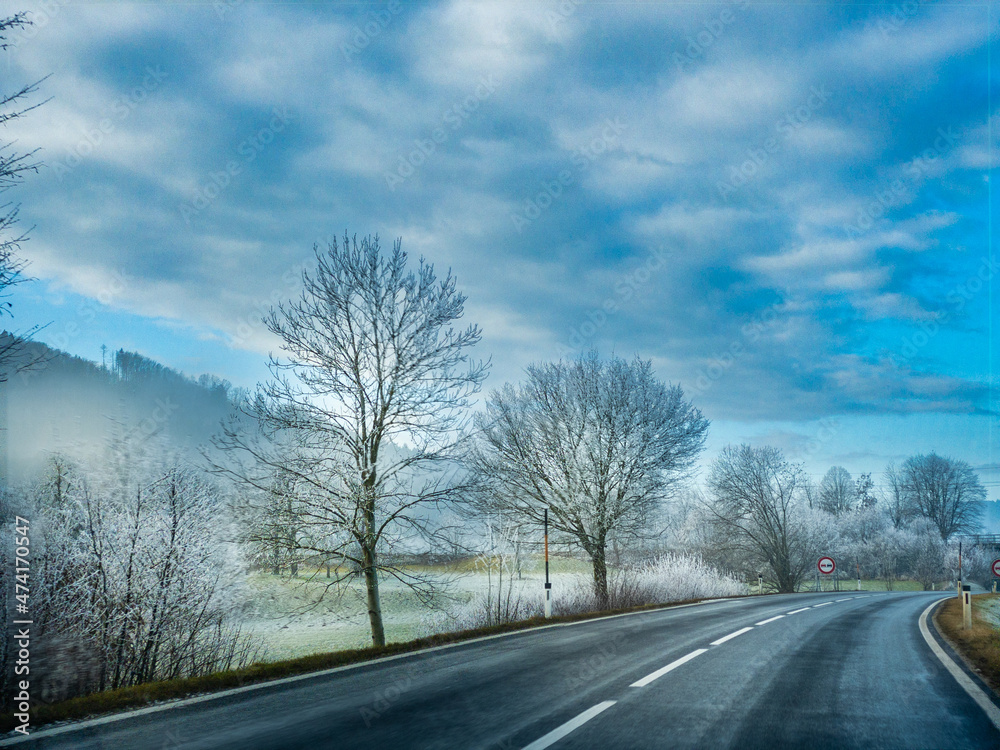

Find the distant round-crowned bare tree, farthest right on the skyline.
xmin=902 ymin=453 xmax=986 ymax=541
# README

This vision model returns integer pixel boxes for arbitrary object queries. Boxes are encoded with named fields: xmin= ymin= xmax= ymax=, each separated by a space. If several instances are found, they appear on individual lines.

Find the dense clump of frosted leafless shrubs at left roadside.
xmin=3 ymin=445 xmax=259 ymax=701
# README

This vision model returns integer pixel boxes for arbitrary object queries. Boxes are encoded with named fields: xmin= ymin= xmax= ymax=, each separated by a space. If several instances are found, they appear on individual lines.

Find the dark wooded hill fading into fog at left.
xmin=0 ymin=332 xmax=241 ymax=482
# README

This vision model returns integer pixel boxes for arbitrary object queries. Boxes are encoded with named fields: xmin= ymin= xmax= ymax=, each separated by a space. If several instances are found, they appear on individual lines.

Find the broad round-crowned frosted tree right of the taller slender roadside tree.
xmin=470 ymin=353 xmax=708 ymax=605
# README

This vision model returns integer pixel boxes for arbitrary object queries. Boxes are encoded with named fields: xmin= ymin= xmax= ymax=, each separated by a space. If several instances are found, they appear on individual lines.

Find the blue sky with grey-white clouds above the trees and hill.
xmin=0 ymin=0 xmax=1000 ymax=490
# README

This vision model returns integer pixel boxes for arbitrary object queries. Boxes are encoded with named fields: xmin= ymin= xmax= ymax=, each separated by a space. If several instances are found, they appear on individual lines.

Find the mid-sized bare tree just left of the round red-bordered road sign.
xmin=706 ymin=445 xmax=824 ymax=592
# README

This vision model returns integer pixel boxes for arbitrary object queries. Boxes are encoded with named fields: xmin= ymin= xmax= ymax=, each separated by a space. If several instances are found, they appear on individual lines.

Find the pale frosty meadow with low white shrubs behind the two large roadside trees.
xmin=244 ymin=554 xmax=749 ymax=660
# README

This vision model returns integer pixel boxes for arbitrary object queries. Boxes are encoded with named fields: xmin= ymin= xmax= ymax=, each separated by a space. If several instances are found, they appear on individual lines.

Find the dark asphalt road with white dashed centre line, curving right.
xmin=7 ymin=592 xmax=1000 ymax=750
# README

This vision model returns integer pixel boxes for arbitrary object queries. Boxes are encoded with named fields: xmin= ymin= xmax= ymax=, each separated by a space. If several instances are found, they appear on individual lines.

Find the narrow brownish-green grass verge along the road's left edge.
xmin=0 ymin=599 xmax=710 ymax=732
